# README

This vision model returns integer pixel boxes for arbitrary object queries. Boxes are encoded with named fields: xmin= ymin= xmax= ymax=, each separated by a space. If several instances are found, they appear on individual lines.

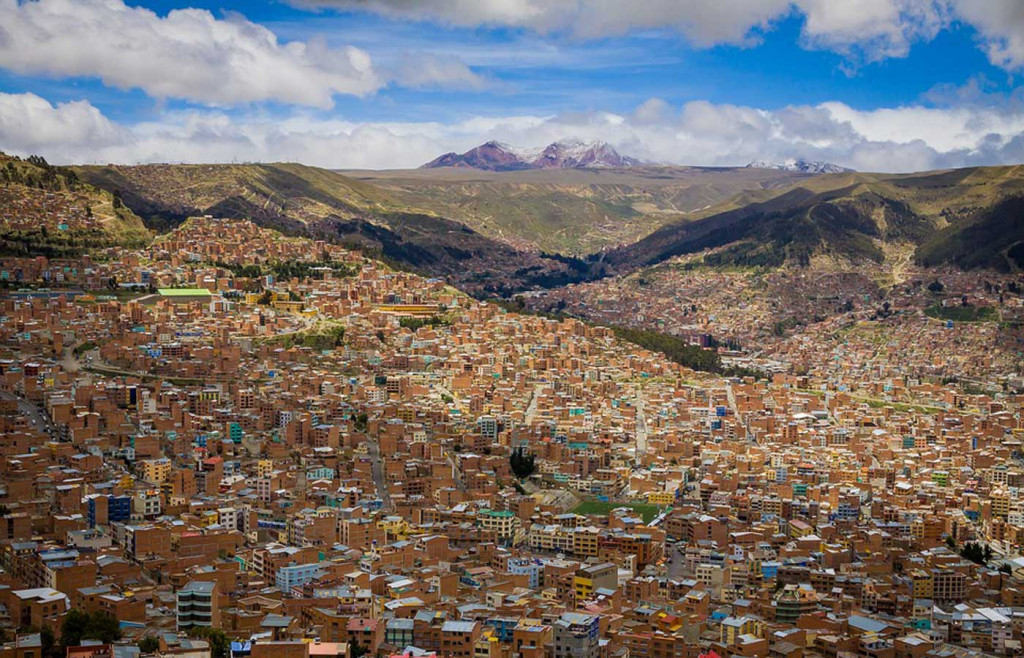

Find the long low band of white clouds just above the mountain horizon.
xmin=6 ymin=94 xmax=1024 ymax=172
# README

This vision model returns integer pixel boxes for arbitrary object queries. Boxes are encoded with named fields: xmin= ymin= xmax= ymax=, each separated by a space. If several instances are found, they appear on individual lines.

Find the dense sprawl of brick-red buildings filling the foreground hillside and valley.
xmin=0 ymin=217 xmax=1024 ymax=658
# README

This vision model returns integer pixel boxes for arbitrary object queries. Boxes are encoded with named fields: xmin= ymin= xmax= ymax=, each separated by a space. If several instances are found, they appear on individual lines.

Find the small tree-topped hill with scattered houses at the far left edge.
xmin=0 ymin=153 xmax=151 ymax=257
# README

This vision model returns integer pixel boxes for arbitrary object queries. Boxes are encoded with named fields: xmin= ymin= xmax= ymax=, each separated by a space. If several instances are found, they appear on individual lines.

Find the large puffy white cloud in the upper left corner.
xmin=0 ymin=0 xmax=383 ymax=107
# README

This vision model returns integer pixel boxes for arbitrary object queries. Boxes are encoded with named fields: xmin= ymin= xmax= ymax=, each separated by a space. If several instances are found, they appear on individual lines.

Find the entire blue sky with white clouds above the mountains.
xmin=0 ymin=0 xmax=1024 ymax=172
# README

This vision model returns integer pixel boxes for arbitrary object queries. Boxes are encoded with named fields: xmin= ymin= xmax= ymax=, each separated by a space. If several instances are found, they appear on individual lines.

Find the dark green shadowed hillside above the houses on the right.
xmin=601 ymin=167 xmax=1024 ymax=272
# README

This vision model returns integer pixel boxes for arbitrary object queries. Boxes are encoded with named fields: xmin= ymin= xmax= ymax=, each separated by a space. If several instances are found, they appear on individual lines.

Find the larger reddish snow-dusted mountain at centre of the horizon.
xmin=421 ymin=139 xmax=643 ymax=171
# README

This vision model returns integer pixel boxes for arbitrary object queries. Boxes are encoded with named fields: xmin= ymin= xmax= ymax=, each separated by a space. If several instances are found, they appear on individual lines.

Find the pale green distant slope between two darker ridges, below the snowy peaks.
xmin=344 ymin=166 xmax=807 ymax=255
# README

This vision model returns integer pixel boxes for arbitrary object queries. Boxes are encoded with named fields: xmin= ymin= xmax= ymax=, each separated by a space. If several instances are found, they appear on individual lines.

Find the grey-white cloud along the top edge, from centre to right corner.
xmin=292 ymin=0 xmax=1024 ymax=71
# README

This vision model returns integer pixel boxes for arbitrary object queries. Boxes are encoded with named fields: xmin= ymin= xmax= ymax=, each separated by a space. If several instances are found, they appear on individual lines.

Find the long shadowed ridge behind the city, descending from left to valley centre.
xmin=76 ymin=164 xmax=570 ymax=293
